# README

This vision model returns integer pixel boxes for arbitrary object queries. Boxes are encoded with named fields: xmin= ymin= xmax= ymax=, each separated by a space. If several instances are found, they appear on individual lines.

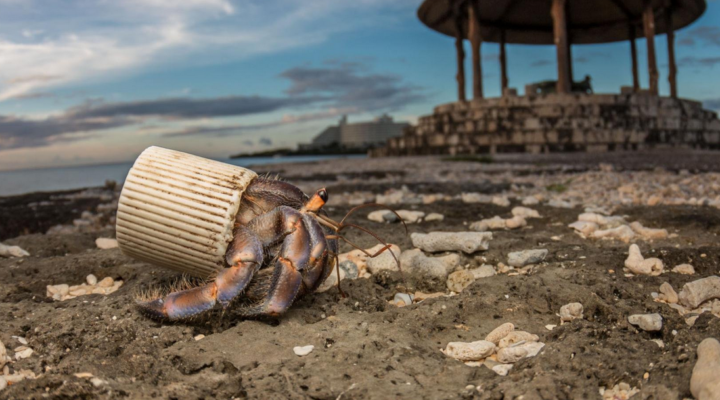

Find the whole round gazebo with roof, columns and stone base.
xmin=370 ymin=0 xmax=720 ymax=156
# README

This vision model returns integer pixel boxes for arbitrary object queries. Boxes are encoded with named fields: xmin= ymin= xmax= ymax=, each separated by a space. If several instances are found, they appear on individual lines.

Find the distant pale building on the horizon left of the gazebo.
xmin=299 ymin=114 xmax=408 ymax=150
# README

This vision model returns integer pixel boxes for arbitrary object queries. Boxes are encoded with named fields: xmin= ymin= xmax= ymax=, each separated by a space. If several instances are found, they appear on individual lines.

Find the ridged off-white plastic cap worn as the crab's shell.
xmin=116 ymin=146 xmax=257 ymax=278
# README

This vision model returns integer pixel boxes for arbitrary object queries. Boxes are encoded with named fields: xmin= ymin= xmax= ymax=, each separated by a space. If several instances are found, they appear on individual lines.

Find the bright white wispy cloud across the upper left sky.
xmin=0 ymin=0 xmax=416 ymax=101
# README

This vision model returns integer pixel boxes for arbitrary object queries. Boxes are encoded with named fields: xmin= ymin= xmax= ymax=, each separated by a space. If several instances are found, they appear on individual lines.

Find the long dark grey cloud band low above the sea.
xmin=0 ymin=63 xmax=425 ymax=150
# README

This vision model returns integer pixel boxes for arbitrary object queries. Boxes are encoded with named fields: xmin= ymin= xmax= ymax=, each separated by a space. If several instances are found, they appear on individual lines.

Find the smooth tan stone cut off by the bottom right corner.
xmin=690 ymin=338 xmax=720 ymax=400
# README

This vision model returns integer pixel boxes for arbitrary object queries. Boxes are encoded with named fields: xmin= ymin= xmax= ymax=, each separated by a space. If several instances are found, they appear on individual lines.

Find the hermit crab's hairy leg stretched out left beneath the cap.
xmin=138 ymin=227 xmax=263 ymax=320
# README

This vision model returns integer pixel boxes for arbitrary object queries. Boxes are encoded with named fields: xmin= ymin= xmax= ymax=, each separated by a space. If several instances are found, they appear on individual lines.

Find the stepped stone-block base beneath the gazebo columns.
xmin=371 ymin=93 xmax=720 ymax=156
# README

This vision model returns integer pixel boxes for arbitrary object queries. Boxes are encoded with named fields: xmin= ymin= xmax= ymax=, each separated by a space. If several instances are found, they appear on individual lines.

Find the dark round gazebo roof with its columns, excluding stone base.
xmin=418 ymin=0 xmax=706 ymax=101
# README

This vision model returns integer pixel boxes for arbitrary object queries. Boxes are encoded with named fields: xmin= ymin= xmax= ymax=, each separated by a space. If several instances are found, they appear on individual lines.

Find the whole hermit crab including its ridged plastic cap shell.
xmin=116 ymin=147 xmax=400 ymax=320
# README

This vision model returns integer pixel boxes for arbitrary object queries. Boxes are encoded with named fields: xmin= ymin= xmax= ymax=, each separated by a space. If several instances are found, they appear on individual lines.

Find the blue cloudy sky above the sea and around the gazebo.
xmin=0 ymin=0 xmax=720 ymax=170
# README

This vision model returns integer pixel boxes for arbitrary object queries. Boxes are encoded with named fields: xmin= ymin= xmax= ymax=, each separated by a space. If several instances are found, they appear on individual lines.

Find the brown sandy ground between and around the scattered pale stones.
xmin=0 ymin=152 xmax=720 ymax=399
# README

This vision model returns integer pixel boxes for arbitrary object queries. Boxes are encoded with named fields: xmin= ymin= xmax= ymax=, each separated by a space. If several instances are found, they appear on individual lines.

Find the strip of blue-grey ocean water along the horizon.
xmin=0 ymin=155 xmax=365 ymax=196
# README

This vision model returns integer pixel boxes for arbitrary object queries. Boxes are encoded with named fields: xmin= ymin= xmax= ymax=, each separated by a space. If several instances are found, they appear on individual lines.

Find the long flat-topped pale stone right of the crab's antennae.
xmin=410 ymin=232 xmax=492 ymax=254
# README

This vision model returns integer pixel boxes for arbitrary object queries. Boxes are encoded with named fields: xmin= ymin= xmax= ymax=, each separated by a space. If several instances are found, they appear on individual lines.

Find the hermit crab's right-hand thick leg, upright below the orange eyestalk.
xmin=240 ymin=211 xmax=318 ymax=317
